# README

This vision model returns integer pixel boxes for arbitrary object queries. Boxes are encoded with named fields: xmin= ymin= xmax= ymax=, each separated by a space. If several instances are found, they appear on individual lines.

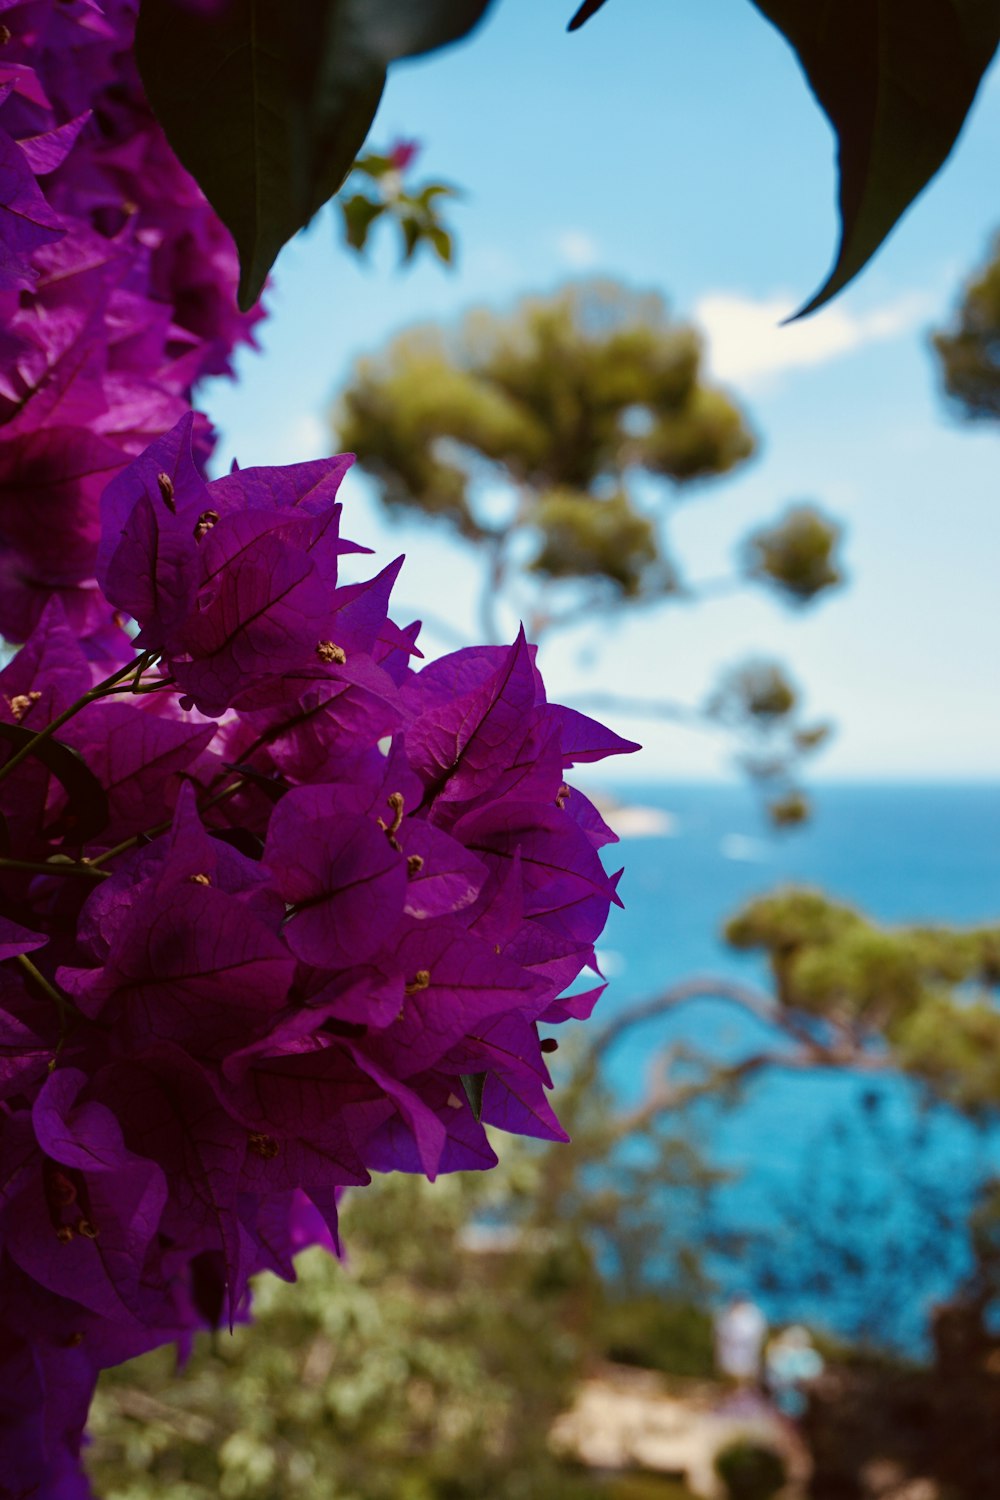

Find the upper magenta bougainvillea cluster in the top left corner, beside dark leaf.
xmin=0 ymin=0 xmax=261 ymax=641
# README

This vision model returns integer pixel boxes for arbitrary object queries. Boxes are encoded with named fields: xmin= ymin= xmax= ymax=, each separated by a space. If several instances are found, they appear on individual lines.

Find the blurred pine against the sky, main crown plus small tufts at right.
xmin=333 ymin=281 xmax=841 ymax=828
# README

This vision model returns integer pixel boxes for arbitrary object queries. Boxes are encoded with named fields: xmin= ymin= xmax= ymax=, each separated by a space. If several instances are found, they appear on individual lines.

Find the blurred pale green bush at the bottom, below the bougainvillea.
xmin=83 ymin=1178 xmax=579 ymax=1500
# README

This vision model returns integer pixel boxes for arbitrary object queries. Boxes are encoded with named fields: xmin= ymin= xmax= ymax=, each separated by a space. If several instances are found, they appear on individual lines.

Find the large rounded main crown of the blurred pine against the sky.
xmin=334 ymin=282 xmax=754 ymax=600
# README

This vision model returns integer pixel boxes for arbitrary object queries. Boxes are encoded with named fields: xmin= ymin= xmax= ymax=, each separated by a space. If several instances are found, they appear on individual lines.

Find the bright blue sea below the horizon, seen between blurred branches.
xmin=581 ymin=785 xmax=1000 ymax=1352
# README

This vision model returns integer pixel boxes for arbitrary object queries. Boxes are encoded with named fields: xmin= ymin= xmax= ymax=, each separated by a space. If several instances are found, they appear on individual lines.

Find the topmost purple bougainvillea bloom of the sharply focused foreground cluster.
xmin=97 ymin=417 xmax=413 ymax=714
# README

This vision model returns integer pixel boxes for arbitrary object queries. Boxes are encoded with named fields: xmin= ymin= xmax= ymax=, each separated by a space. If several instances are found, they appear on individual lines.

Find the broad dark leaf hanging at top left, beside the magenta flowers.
xmin=135 ymin=0 xmax=490 ymax=309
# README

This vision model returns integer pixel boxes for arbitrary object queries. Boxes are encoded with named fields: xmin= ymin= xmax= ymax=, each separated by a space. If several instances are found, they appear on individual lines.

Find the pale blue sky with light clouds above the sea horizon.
xmin=202 ymin=0 xmax=1000 ymax=780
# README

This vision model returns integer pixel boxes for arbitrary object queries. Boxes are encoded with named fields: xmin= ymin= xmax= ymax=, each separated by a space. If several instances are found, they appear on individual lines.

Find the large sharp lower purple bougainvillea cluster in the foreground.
xmin=0 ymin=416 xmax=633 ymax=1496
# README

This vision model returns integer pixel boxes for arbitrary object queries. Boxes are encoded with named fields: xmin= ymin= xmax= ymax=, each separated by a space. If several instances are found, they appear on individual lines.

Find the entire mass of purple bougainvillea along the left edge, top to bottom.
xmin=0 ymin=0 xmax=636 ymax=1500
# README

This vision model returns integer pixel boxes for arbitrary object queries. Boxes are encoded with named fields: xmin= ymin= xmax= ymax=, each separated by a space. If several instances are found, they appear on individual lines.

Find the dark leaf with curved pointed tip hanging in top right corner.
xmin=753 ymin=0 xmax=1000 ymax=317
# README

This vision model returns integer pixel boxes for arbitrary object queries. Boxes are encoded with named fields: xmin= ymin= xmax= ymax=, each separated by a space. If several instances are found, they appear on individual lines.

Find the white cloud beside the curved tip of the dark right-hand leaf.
xmin=694 ymin=291 xmax=931 ymax=387
